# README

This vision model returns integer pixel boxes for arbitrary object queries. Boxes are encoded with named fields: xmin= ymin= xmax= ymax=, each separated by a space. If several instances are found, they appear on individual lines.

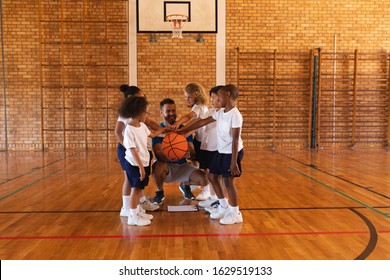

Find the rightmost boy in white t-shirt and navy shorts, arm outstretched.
xmin=180 ymin=85 xmax=244 ymax=224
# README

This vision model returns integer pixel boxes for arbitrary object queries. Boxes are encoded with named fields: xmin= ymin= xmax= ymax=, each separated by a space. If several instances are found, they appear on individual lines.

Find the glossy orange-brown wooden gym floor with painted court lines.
xmin=0 ymin=149 xmax=390 ymax=260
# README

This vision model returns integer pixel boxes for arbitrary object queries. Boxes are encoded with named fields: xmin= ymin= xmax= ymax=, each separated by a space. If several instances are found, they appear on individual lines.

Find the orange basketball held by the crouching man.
xmin=162 ymin=132 xmax=188 ymax=160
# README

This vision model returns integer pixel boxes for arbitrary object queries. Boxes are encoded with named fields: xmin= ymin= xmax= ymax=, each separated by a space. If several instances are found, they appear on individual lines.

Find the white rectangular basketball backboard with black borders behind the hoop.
xmin=137 ymin=0 xmax=217 ymax=33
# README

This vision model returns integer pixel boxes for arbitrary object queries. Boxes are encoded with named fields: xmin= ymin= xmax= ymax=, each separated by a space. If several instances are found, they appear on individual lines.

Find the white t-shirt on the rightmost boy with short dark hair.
xmin=213 ymin=107 xmax=244 ymax=154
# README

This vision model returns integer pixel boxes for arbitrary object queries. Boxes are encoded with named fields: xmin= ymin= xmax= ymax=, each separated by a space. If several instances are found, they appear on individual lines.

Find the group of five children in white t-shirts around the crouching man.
xmin=115 ymin=83 xmax=243 ymax=226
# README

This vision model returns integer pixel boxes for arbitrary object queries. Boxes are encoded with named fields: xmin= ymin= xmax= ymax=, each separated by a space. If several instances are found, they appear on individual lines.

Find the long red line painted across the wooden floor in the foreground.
xmin=0 ymin=230 xmax=390 ymax=240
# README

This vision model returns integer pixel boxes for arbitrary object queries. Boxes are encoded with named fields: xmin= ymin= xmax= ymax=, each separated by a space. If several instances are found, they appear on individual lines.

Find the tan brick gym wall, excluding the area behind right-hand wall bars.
xmin=0 ymin=0 xmax=390 ymax=150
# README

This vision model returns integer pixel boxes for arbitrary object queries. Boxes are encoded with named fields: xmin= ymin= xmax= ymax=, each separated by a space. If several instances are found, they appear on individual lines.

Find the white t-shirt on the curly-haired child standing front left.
xmin=123 ymin=123 xmax=150 ymax=166
